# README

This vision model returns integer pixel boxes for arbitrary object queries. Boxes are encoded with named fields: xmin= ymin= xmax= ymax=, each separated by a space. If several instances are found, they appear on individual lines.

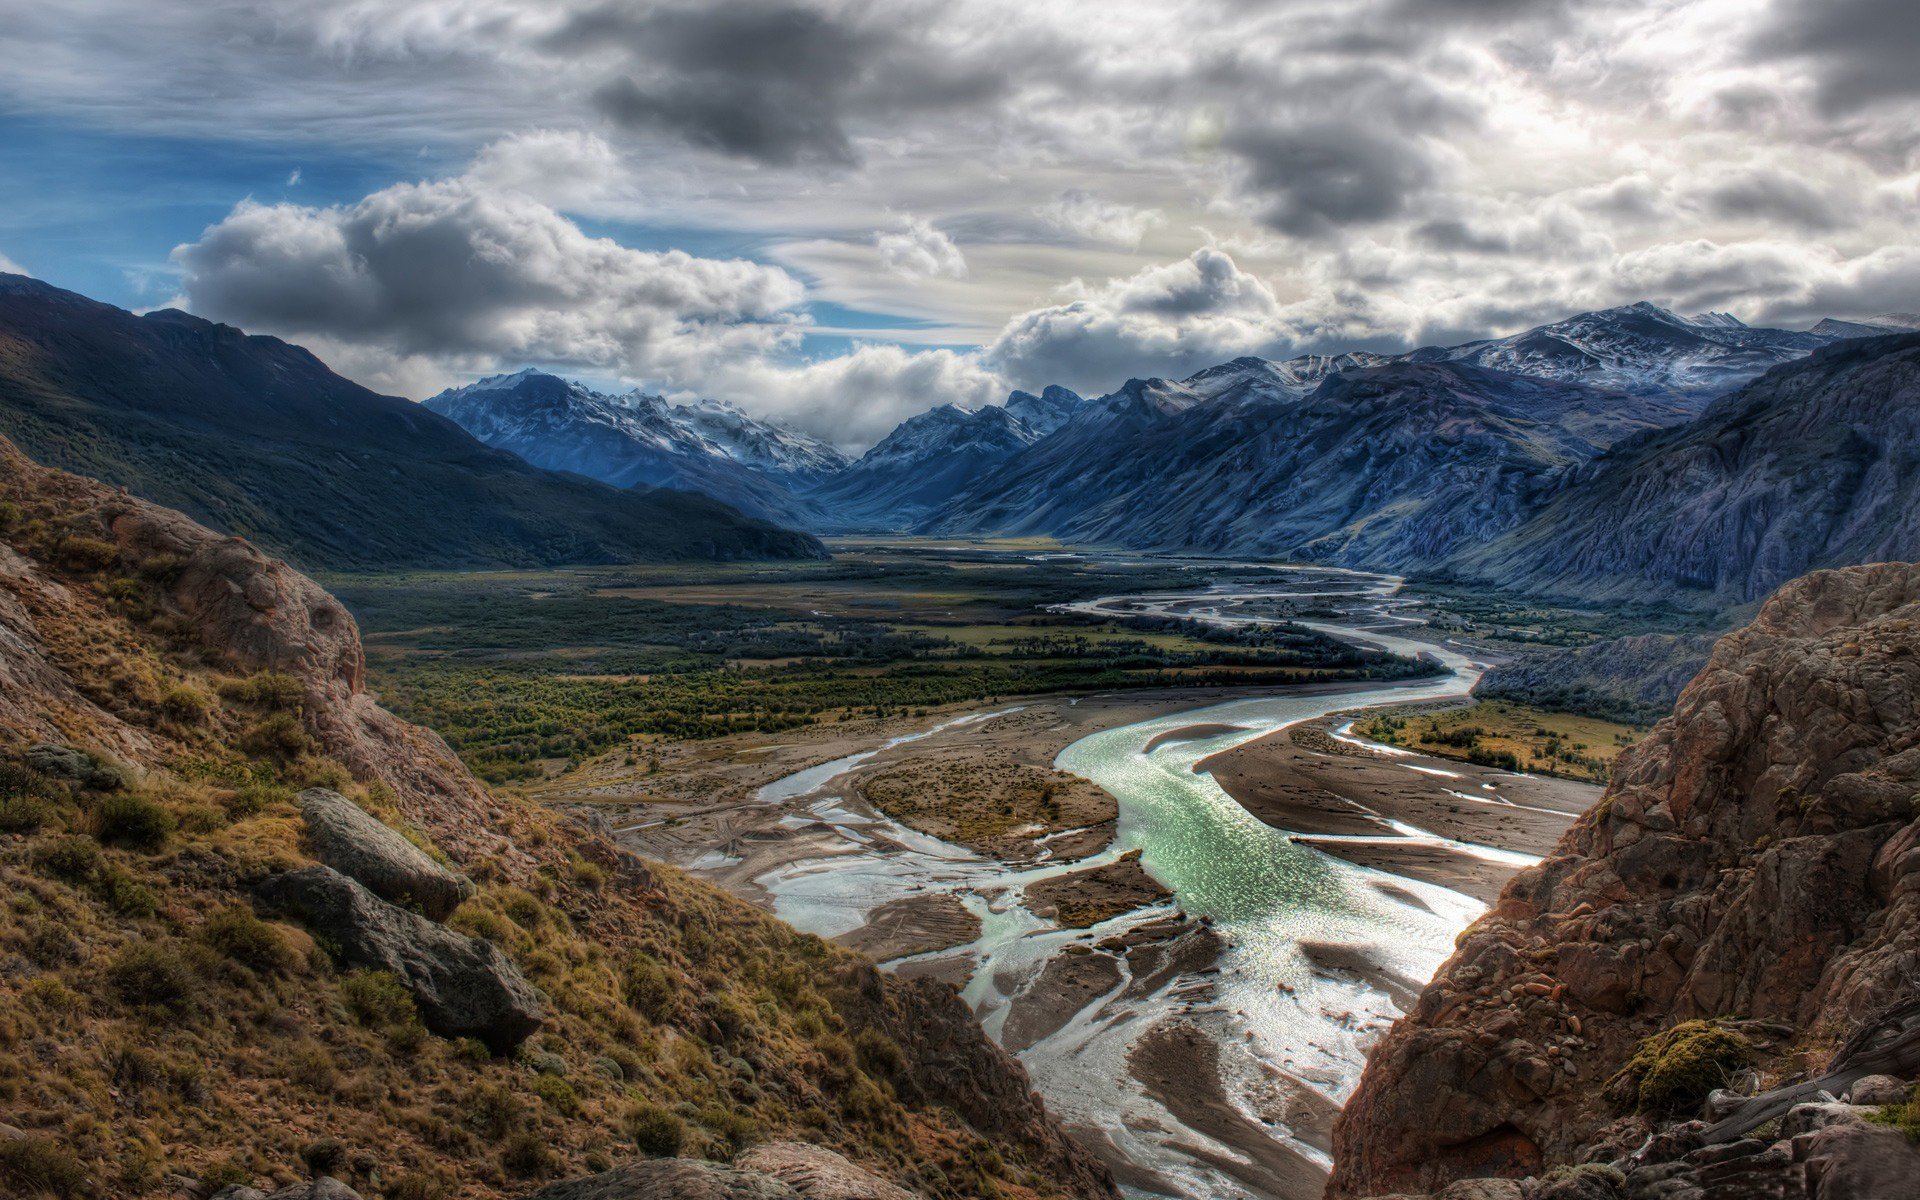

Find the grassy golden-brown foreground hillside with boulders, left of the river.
xmin=0 ymin=440 xmax=1114 ymax=1200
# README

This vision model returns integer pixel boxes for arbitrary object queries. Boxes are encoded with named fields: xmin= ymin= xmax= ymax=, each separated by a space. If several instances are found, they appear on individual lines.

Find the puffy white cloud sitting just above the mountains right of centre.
xmin=985 ymin=250 xmax=1281 ymax=388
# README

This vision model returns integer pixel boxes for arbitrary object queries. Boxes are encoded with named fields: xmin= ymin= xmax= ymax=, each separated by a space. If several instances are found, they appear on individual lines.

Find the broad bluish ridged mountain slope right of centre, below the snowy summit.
xmin=925 ymin=359 xmax=1684 ymax=568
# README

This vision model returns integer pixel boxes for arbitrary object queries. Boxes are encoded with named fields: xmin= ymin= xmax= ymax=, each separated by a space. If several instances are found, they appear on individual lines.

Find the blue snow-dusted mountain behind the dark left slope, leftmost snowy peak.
xmin=422 ymin=369 xmax=847 ymax=522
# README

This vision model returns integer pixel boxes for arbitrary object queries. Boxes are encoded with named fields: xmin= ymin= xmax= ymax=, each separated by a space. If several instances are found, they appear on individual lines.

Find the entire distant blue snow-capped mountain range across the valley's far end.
xmin=412 ymin=303 xmax=1920 ymax=595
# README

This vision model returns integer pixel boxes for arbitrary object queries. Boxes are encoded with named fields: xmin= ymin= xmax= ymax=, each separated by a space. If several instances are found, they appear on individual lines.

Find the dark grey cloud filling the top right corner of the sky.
xmin=1753 ymin=0 xmax=1920 ymax=113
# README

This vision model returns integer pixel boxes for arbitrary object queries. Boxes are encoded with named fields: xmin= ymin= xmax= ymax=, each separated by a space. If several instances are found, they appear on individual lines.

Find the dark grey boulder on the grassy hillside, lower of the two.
xmin=259 ymin=866 xmax=541 ymax=1052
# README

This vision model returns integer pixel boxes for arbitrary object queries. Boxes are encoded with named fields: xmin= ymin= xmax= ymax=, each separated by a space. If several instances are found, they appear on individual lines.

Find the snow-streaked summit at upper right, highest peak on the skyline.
xmin=1405 ymin=301 xmax=1828 ymax=399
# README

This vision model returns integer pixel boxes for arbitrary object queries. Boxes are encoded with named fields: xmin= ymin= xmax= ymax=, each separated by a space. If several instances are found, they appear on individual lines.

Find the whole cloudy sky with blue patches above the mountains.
xmin=0 ymin=0 xmax=1920 ymax=449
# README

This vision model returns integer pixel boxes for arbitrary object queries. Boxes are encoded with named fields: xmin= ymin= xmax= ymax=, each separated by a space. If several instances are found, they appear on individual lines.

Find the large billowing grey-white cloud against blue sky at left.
xmin=173 ymin=157 xmax=804 ymax=378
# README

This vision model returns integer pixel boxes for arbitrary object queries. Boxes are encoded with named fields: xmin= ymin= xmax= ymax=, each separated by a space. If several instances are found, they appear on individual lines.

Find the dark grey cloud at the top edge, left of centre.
xmin=547 ymin=0 xmax=1014 ymax=167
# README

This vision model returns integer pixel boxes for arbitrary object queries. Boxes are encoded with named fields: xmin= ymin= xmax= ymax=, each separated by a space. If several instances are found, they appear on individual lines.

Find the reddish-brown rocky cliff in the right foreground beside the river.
xmin=1329 ymin=564 xmax=1920 ymax=1198
